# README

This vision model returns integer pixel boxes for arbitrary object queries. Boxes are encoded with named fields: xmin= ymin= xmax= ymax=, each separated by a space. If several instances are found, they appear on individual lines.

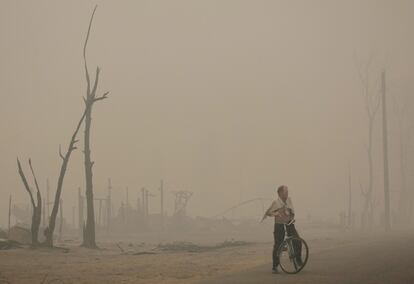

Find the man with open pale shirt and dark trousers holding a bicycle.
xmin=262 ymin=185 xmax=302 ymax=273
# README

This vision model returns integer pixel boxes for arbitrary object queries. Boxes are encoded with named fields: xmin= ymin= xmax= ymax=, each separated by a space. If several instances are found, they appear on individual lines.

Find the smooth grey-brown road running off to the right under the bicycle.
xmin=201 ymin=232 xmax=414 ymax=284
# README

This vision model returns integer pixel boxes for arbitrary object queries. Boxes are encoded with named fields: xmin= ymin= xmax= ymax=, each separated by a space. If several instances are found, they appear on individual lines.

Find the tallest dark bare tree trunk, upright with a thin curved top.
xmin=82 ymin=6 xmax=109 ymax=248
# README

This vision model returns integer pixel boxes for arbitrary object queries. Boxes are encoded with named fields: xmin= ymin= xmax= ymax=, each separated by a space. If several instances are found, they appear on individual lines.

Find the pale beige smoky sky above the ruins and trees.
xmin=0 ymin=0 xmax=414 ymax=224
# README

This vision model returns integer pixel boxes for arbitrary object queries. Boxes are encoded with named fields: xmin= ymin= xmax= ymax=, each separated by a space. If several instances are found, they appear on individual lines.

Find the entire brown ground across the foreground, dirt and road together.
xmin=0 ymin=226 xmax=414 ymax=284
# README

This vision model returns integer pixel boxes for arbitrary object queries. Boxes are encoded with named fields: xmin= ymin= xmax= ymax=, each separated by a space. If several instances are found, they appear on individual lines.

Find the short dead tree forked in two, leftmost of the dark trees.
xmin=17 ymin=158 xmax=42 ymax=246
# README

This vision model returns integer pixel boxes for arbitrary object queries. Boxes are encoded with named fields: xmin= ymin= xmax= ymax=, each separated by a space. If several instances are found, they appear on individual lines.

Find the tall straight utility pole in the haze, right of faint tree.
xmin=381 ymin=70 xmax=391 ymax=231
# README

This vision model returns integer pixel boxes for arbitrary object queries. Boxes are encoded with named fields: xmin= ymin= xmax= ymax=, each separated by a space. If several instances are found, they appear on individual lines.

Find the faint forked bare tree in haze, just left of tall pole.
xmin=355 ymin=55 xmax=380 ymax=228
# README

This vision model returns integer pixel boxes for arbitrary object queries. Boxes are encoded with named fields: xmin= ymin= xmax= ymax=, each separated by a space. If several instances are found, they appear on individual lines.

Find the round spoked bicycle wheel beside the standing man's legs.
xmin=277 ymin=237 xmax=309 ymax=274
